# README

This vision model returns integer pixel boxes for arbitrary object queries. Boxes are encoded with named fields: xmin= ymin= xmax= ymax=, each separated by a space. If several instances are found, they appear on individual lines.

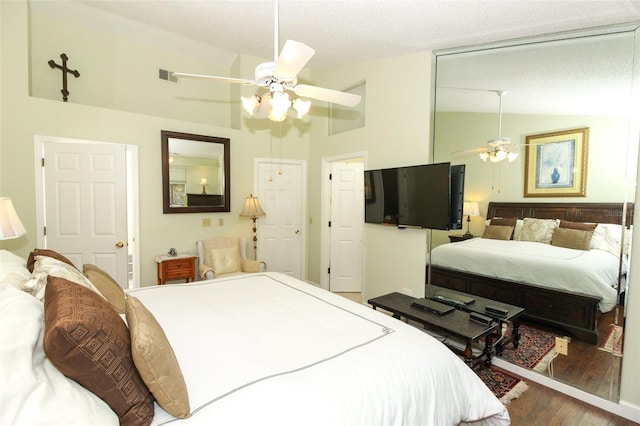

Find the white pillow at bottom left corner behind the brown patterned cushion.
xmin=0 ymin=286 xmax=119 ymax=426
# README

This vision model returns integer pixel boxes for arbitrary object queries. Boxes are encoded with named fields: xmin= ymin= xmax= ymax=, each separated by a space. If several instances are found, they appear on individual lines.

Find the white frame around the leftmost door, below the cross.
xmin=33 ymin=135 xmax=140 ymax=288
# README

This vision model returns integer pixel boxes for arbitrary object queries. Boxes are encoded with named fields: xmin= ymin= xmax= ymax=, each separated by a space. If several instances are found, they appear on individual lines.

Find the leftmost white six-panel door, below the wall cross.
xmin=44 ymin=142 xmax=128 ymax=288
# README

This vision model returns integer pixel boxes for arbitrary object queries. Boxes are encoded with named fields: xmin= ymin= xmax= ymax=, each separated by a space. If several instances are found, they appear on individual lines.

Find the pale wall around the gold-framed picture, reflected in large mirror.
xmin=434 ymin=112 xmax=638 ymax=245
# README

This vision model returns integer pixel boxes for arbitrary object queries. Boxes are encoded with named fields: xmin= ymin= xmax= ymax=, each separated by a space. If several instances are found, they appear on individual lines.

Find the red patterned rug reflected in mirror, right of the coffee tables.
xmin=501 ymin=325 xmax=556 ymax=371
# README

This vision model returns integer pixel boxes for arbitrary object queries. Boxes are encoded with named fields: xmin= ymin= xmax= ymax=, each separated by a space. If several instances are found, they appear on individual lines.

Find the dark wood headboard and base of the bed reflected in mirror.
xmin=427 ymin=202 xmax=633 ymax=344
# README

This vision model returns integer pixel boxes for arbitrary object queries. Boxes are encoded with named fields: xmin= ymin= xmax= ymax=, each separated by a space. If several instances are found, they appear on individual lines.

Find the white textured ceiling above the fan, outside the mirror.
xmin=30 ymin=0 xmax=640 ymax=67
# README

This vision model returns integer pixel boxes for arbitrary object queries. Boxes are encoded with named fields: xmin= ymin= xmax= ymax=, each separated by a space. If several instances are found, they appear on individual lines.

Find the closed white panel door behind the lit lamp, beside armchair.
xmin=256 ymin=160 xmax=305 ymax=279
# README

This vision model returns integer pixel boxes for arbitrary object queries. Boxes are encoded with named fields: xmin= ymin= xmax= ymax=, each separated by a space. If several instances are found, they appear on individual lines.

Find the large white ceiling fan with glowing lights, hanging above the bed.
xmin=173 ymin=0 xmax=360 ymax=121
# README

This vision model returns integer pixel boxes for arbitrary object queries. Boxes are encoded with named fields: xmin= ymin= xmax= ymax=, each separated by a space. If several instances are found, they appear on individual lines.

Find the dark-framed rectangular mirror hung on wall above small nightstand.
xmin=161 ymin=130 xmax=231 ymax=213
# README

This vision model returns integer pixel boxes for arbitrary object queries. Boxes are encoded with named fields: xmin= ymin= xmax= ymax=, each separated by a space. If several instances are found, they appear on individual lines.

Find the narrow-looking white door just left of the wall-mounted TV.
xmin=329 ymin=162 xmax=364 ymax=292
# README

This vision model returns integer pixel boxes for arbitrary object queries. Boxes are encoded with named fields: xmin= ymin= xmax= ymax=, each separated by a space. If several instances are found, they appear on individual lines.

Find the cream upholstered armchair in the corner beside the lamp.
xmin=196 ymin=237 xmax=267 ymax=279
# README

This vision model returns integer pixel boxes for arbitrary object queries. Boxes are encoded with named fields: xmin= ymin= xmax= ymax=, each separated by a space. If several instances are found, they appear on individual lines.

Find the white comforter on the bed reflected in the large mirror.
xmin=431 ymin=238 xmax=619 ymax=312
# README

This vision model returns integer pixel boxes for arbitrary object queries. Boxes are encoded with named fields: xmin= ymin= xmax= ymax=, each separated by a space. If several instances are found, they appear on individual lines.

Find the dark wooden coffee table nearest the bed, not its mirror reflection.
xmin=369 ymin=292 xmax=498 ymax=367
